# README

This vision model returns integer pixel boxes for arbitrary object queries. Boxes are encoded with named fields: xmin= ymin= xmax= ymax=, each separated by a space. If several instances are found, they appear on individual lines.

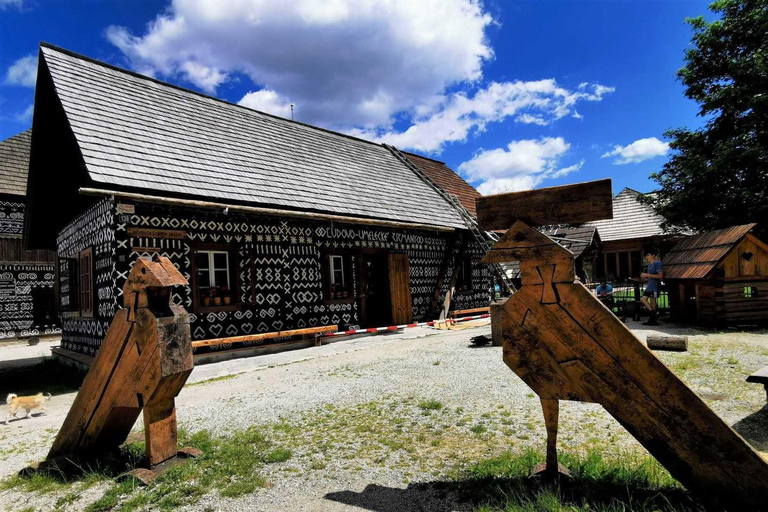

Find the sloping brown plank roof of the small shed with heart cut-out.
xmin=664 ymin=224 xmax=756 ymax=279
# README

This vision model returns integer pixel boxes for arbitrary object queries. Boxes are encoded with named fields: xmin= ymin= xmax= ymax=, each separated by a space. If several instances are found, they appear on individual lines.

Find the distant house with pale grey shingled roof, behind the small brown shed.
xmin=584 ymin=188 xmax=685 ymax=281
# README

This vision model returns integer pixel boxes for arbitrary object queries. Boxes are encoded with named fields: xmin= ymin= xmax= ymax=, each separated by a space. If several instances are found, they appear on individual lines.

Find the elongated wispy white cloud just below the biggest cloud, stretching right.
xmin=351 ymin=78 xmax=614 ymax=153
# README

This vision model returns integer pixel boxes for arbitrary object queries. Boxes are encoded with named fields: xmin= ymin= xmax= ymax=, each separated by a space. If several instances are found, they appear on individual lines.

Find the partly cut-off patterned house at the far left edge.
xmin=0 ymin=130 xmax=60 ymax=339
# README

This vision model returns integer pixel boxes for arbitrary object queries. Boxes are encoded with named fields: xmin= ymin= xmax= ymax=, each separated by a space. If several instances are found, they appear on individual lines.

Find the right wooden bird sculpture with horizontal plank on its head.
xmin=477 ymin=180 xmax=768 ymax=510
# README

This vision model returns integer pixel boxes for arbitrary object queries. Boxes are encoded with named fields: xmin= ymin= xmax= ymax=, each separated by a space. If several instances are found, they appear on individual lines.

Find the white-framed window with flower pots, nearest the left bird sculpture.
xmin=195 ymin=250 xmax=234 ymax=307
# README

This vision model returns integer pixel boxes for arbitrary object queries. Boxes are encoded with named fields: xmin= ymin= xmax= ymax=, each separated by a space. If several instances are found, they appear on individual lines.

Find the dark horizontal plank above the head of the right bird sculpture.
xmin=475 ymin=179 xmax=613 ymax=231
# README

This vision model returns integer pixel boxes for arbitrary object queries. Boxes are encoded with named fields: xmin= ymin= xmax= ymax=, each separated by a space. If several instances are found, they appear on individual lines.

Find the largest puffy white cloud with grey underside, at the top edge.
xmin=106 ymin=0 xmax=493 ymax=128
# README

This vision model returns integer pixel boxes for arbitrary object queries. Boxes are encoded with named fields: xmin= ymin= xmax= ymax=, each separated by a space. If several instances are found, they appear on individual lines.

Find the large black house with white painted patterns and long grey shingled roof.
xmin=25 ymin=44 xmax=492 ymax=355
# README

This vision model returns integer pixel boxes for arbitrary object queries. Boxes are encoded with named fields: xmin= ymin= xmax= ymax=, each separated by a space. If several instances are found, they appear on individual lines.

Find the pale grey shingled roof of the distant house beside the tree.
xmin=585 ymin=188 xmax=672 ymax=242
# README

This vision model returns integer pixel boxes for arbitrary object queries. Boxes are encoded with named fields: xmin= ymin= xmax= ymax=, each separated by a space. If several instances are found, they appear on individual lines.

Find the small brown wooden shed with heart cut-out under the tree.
xmin=663 ymin=224 xmax=768 ymax=326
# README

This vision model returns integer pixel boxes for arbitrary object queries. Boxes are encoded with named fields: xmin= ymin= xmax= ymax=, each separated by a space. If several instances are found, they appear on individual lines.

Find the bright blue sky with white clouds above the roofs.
xmin=0 ymin=0 xmax=709 ymax=193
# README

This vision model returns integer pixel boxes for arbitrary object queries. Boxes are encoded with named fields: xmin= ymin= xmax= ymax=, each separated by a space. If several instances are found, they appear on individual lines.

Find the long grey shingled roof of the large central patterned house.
xmin=41 ymin=44 xmax=464 ymax=228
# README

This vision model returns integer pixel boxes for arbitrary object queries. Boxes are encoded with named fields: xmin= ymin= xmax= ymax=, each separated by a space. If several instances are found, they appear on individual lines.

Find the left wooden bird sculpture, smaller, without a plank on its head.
xmin=48 ymin=256 xmax=194 ymax=468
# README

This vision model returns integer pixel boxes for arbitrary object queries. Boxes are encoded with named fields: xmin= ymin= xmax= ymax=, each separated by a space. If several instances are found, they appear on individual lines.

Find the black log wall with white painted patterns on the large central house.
xmin=59 ymin=199 xmax=491 ymax=355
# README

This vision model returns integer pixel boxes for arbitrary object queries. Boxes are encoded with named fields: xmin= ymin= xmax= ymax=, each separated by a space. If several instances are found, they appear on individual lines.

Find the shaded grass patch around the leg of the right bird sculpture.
xmin=453 ymin=451 xmax=704 ymax=512
